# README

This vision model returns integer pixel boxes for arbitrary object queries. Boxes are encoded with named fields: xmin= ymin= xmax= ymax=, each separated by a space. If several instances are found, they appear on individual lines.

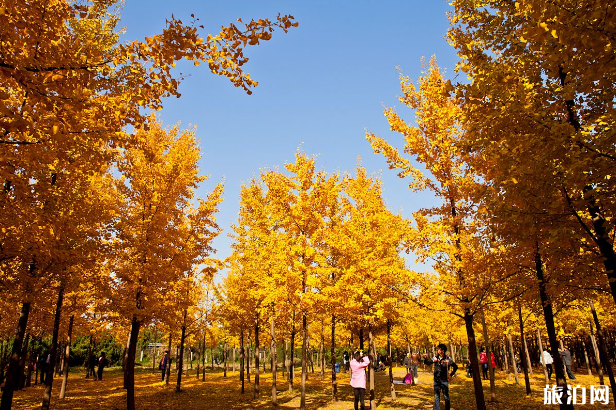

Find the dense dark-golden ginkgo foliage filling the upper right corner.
xmin=449 ymin=0 xmax=616 ymax=303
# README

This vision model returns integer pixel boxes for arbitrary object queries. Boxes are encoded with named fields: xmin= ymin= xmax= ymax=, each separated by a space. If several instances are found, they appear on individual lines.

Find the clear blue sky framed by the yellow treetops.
xmin=121 ymin=0 xmax=457 ymax=272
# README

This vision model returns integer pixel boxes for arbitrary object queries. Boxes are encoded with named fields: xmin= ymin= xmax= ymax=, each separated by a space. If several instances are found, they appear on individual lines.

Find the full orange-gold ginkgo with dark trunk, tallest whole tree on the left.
xmin=110 ymin=116 xmax=222 ymax=409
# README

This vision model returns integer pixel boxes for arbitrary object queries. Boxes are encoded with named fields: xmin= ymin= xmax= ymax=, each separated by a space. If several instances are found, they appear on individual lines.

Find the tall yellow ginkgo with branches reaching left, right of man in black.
xmin=366 ymin=57 xmax=493 ymax=409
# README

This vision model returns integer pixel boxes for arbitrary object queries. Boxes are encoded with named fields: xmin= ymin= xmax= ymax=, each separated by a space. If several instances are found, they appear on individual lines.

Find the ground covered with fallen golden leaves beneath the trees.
xmin=13 ymin=368 xmax=613 ymax=410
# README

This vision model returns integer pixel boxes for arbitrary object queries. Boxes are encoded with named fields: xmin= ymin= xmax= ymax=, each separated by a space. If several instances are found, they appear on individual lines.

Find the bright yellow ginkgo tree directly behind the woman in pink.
xmin=332 ymin=165 xmax=412 ymax=409
